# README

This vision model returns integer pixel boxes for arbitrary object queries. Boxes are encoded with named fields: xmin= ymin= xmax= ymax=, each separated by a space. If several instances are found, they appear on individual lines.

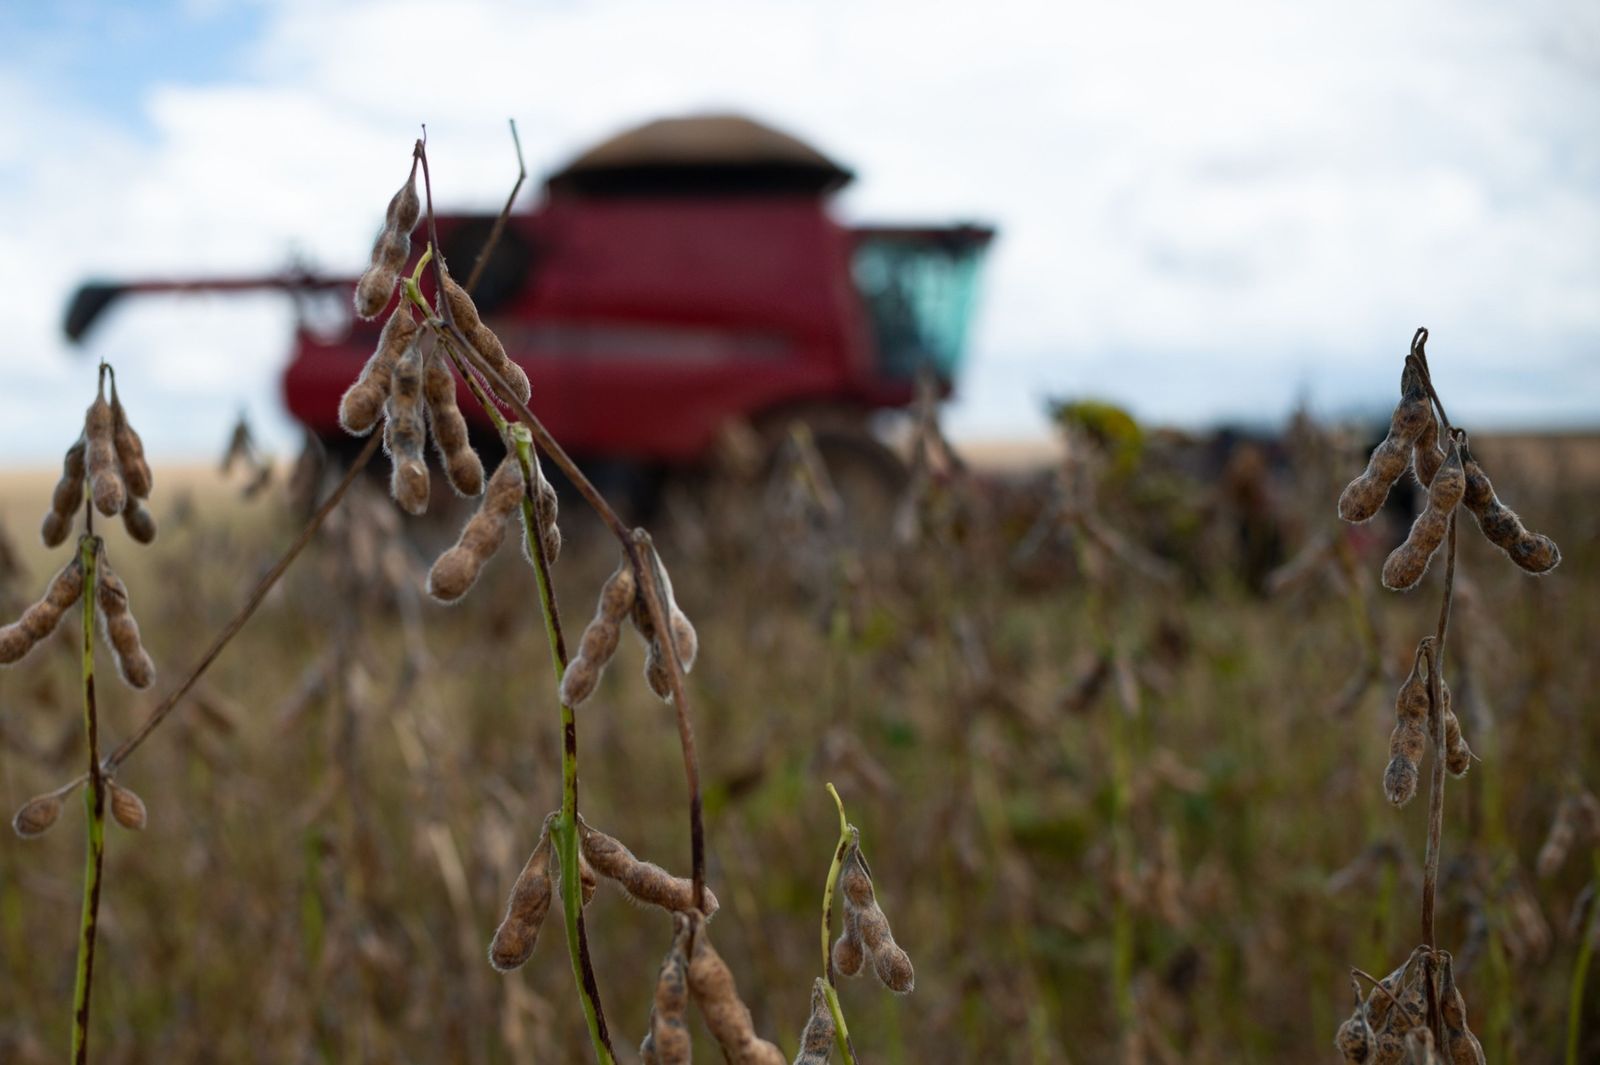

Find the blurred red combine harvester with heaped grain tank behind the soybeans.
xmin=66 ymin=115 xmax=994 ymax=502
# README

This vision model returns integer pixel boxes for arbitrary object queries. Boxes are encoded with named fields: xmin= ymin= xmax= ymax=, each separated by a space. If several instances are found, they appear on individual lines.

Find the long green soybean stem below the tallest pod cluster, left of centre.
xmin=508 ymin=425 xmax=614 ymax=1065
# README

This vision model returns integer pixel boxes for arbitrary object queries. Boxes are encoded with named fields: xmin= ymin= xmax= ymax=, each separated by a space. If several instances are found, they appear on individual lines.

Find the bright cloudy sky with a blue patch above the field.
xmin=0 ymin=0 xmax=1600 ymax=464
